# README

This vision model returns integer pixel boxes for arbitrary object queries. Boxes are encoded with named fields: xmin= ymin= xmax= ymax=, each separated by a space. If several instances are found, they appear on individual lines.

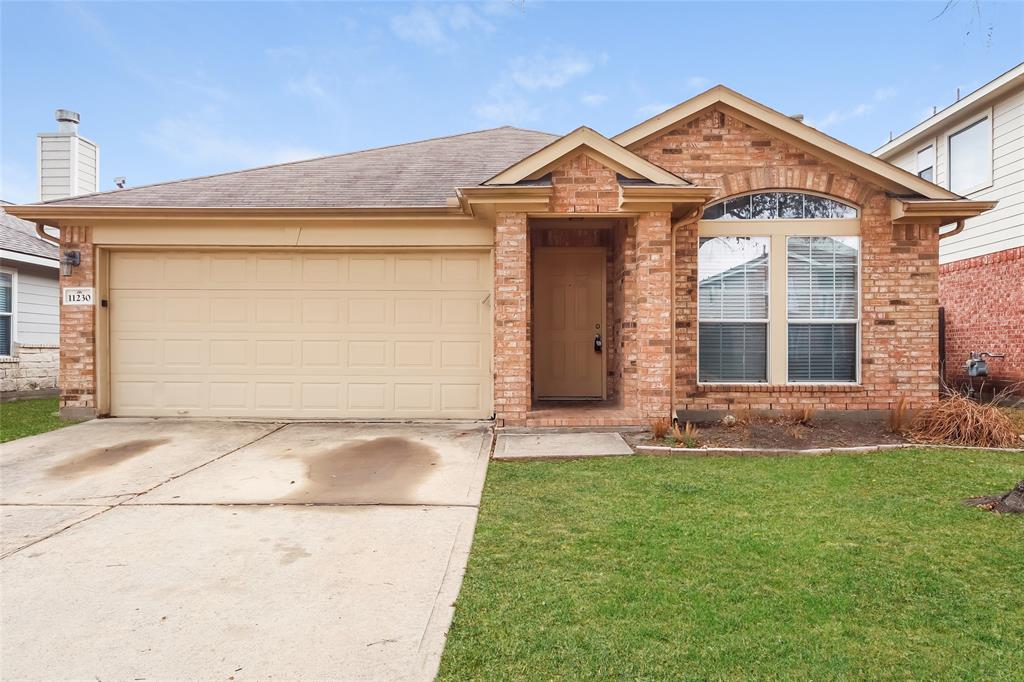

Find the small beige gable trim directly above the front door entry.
xmin=483 ymin=126 xmax=691 ymax=186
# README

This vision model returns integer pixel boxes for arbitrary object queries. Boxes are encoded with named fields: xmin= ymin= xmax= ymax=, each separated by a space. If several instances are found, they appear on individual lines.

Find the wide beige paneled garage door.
xmin=110 ymin=252 xmax=492 ymax=419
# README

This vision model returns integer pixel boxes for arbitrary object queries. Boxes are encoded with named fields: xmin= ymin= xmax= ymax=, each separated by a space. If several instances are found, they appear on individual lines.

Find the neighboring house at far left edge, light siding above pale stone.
xmin=0 ymin=202 xmax=60 ymax=398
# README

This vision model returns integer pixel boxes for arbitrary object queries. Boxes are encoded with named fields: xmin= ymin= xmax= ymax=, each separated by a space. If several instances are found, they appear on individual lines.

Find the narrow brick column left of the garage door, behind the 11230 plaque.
xmin=59 ymin=227 xmax=96 ymax=419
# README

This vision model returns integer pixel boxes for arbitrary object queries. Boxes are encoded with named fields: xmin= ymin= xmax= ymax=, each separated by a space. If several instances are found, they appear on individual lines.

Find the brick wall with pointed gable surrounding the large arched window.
xmin=633 ymin=110 xmax=938 ymax=410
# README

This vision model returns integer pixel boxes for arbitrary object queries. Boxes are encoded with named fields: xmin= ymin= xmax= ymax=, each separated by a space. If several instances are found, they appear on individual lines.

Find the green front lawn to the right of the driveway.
xmin=440 ymin=450 xmax=1024 ymax=680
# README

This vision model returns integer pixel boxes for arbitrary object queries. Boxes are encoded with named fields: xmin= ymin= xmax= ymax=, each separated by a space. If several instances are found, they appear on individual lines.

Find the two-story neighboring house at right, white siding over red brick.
xmin=874 ymin=63 xmax=1024 ymax=392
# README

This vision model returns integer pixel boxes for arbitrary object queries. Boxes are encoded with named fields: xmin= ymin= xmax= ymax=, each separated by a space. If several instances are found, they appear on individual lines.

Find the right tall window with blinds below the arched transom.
xmin=786 ymin=237 xmax=860 ymax=382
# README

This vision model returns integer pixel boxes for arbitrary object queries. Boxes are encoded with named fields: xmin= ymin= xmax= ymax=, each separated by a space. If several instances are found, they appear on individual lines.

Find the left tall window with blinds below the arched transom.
xmin=697 ymin=237 xmax=770 ymax=382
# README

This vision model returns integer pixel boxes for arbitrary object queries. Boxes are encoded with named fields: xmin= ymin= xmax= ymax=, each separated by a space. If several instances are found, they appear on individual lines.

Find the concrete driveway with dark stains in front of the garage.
xmin=0 ymin=419 xmax=492 ymax=680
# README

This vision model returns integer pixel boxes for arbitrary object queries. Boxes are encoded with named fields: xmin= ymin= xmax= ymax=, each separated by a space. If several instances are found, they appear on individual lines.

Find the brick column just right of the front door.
xmin=636 ymin=211 xmax=672 ymax=419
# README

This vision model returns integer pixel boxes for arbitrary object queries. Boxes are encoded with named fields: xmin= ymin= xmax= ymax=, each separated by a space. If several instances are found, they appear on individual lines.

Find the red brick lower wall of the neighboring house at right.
xmin=939 ymin=247 xmax=1024 ymax=392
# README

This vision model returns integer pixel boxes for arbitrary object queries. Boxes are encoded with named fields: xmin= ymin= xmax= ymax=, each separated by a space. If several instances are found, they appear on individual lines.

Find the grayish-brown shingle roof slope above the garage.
xmin=34 ymin=126 xmax=558 ymax=208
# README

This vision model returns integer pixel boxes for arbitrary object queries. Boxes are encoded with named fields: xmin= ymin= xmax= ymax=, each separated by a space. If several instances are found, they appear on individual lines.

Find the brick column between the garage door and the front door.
xmin=495 ymin=211 xmax=531 ymax=426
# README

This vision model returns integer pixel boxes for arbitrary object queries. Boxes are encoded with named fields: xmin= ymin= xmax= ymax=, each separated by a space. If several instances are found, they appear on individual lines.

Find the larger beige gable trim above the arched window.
xmin=611 ymin=85 xmax=959 ymax=199
